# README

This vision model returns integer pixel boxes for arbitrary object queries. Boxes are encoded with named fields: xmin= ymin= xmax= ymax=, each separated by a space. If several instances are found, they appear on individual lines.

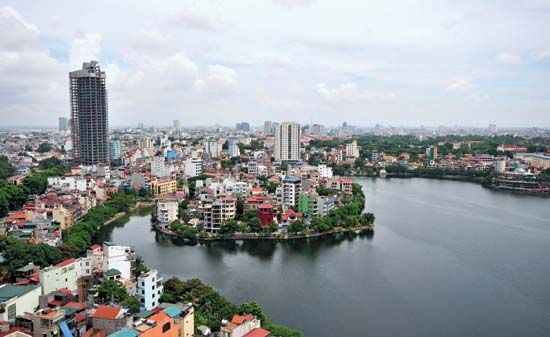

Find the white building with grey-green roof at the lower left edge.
xmin=0 ymin=284 xmax=41 ymax=322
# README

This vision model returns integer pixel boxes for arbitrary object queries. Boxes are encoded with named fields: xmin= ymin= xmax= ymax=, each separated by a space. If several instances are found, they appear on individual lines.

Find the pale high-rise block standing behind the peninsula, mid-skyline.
xmin=275 ymin=122 xmax=301 ymax=161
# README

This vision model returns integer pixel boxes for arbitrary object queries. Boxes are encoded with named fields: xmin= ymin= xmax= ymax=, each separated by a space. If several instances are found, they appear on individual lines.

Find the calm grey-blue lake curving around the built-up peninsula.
xmin=99 ymin=178 xmax=550 ymax=337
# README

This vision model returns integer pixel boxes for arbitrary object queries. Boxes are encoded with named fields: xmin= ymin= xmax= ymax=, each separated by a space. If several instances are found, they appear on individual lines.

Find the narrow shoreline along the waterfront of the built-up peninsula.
xmin=153 ymin=224 xmax=375 ymax=242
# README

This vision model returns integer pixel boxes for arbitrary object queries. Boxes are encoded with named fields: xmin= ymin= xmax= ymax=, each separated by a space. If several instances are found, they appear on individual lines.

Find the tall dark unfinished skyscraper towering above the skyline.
xmin=69 ymin=61 xmax=109 ymax=165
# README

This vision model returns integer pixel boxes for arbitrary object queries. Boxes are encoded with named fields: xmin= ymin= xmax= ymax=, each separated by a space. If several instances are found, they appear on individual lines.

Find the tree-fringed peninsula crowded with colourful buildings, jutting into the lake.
xmin=152 ymin=175 xmax=375 ymax=241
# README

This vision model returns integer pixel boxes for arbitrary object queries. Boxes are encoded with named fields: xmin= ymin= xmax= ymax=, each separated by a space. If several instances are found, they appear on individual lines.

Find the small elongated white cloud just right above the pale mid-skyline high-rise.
xmin=315 ymin=82 xmax=397 ymax=103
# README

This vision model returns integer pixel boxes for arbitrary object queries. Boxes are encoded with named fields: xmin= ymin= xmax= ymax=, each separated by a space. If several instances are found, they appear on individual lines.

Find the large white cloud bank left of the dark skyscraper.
xmin=0 ymin=7 xmax=68 ymax=125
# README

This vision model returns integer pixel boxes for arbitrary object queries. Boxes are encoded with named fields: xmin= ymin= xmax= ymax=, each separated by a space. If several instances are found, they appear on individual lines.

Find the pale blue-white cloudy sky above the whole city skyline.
xmin=0 ymin=0 xmax=550 ymax=127
